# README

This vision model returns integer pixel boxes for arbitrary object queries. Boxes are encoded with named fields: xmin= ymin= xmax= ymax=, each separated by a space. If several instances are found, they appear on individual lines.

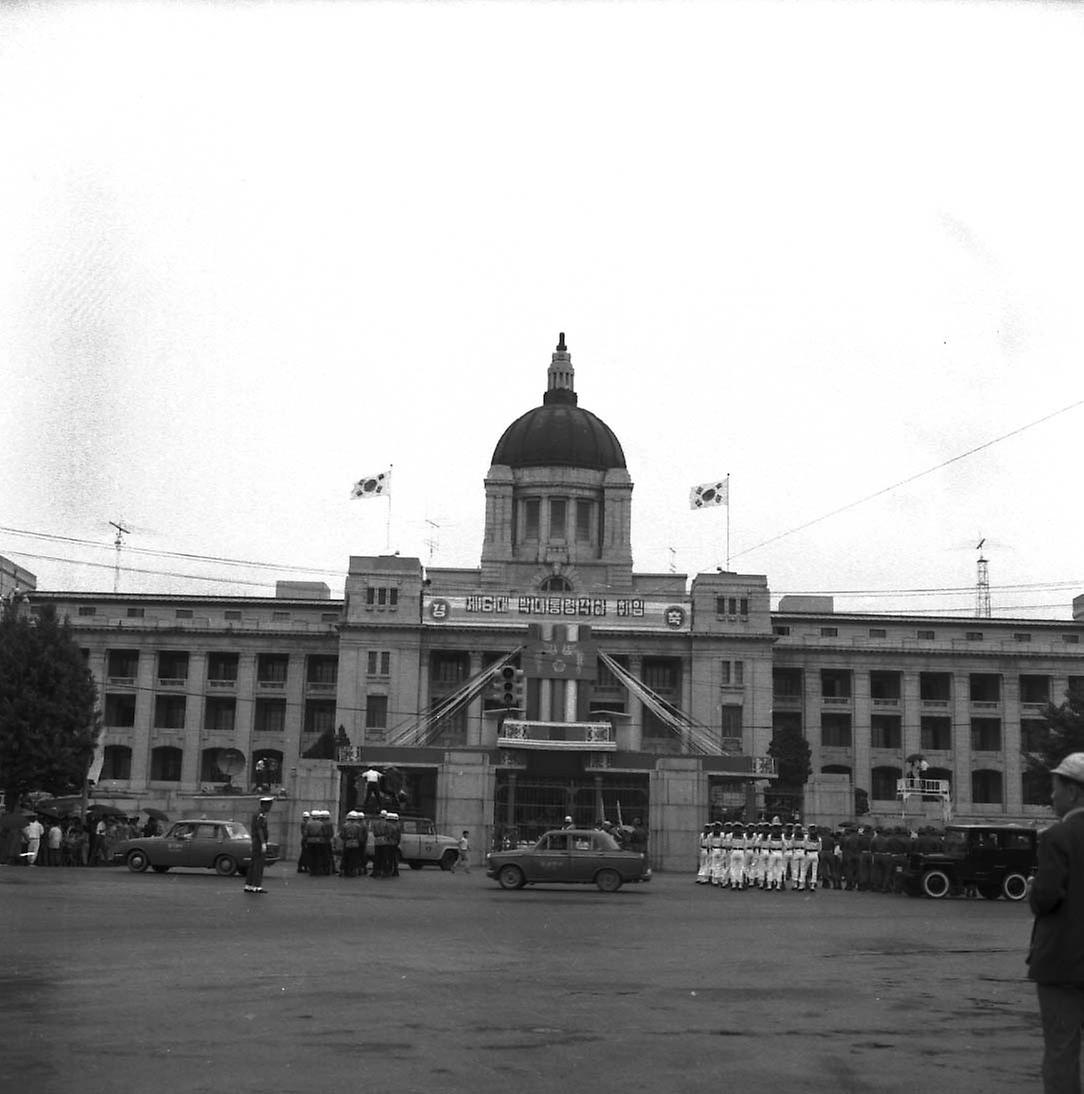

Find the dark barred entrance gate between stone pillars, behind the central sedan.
xmin=493 ymin=771 xmax=650 ymax=847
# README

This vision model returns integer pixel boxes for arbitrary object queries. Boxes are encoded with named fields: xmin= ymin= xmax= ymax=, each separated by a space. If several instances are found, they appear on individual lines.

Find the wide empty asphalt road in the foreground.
xmin=0 ymin=863 xmax=1041 ymax=1094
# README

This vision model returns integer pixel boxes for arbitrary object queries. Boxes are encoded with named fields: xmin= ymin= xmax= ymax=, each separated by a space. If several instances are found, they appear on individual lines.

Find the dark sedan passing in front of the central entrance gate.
xmin=486 ymin=828 xmax=651 ymax=893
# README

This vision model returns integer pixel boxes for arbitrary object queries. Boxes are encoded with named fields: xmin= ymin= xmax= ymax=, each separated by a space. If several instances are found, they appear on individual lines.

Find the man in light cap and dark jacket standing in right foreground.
xmin=1027 ymin=753 xmax=1084 ymax=1094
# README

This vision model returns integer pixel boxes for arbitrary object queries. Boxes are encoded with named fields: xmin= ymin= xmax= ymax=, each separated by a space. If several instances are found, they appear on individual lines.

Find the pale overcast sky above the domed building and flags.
xmin=0 ymin=0 xmax=1084 ymax=618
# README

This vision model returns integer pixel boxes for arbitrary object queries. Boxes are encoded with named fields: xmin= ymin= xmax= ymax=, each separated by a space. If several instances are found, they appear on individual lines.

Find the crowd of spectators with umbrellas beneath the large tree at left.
xmin=0 ymin=813 xmax=162 ymax=866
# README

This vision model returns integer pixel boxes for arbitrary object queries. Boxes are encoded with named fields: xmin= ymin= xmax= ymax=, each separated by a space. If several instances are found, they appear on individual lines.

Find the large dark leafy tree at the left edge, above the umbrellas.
xmin=0 ymin=603 xmax=101 ymax=810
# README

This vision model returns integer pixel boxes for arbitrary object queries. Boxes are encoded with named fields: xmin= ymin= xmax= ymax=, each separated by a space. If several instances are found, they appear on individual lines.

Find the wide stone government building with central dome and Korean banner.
xmin=16 ymin=335 xmax=1084 ymax=870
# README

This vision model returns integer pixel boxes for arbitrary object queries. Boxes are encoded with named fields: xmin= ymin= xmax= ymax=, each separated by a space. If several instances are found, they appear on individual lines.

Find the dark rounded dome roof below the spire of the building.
xmin=492 ymin=392 xmax=625 ymax=470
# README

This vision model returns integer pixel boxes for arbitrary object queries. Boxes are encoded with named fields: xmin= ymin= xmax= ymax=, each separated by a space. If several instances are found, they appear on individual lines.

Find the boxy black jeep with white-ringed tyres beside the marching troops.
xmin=900 ymin=824 xmax=1038 ymax=900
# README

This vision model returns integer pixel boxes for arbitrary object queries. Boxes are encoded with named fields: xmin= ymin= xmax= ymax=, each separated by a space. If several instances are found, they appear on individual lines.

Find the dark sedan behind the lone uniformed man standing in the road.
xmin=113 ymin=819 xmax=279 ymax=877
